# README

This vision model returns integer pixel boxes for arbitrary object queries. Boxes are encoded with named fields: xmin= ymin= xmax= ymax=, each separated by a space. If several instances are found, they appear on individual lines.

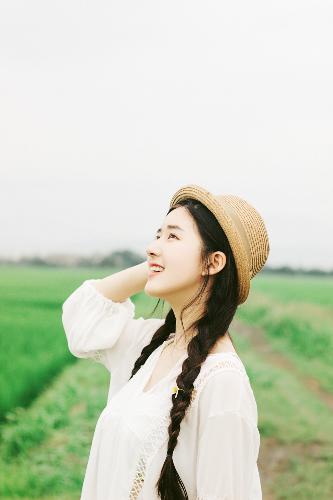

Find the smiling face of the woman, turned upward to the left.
xmin=144 ymin=207 xmax=202 ymax=307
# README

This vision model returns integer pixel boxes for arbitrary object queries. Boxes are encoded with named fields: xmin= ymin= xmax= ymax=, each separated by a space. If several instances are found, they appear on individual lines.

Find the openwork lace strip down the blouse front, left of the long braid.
xmin=129 ymin=414 xmax=170 ymax=500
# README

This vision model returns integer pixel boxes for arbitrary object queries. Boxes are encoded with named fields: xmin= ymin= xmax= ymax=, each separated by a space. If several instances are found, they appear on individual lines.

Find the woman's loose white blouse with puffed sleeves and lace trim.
xmin=62 ymin=279 xmax=262 ymax=500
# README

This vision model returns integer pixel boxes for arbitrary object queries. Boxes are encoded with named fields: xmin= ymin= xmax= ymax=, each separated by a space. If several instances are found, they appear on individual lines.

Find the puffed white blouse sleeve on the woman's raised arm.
xmin=62 ymin=279 xmax=165 ymax=372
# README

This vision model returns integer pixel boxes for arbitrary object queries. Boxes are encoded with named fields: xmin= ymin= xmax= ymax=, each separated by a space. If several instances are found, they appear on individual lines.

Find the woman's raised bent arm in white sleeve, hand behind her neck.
xmin=62 ymin=262 xmax=165 ymax=371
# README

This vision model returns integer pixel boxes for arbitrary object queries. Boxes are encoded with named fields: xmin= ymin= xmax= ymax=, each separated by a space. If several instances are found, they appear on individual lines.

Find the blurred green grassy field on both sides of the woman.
xmin=0 ymin=267 xmax=333 ymax=500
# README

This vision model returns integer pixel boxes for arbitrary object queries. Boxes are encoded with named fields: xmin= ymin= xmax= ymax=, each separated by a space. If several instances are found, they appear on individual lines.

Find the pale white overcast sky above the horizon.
xmin=0 ymin=0 xmax=333 ymax=269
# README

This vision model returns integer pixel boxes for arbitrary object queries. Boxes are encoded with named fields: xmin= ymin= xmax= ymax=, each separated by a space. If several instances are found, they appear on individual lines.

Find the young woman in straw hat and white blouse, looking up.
xmin=62 ymin=184 xmax=269 ymax=500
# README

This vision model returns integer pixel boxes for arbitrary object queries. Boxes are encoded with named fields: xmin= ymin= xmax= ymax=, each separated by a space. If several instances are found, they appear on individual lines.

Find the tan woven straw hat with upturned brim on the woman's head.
xmin=170 ymin=184 xmax=270 ymax=304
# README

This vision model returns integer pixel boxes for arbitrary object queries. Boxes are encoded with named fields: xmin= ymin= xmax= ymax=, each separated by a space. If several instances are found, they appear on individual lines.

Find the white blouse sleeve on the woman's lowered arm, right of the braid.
xmin=196 ymin=370 xmax=258 ymax=500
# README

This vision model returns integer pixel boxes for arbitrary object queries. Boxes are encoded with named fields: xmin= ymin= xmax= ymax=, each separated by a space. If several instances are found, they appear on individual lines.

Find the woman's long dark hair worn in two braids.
xmin=130 ymin=198 xmax=238 ymax=500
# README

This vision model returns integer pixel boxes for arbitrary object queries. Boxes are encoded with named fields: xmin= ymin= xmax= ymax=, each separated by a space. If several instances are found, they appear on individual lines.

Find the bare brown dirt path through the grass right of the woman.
xmin=232 ymin=319 xmax=333 ymax=500
